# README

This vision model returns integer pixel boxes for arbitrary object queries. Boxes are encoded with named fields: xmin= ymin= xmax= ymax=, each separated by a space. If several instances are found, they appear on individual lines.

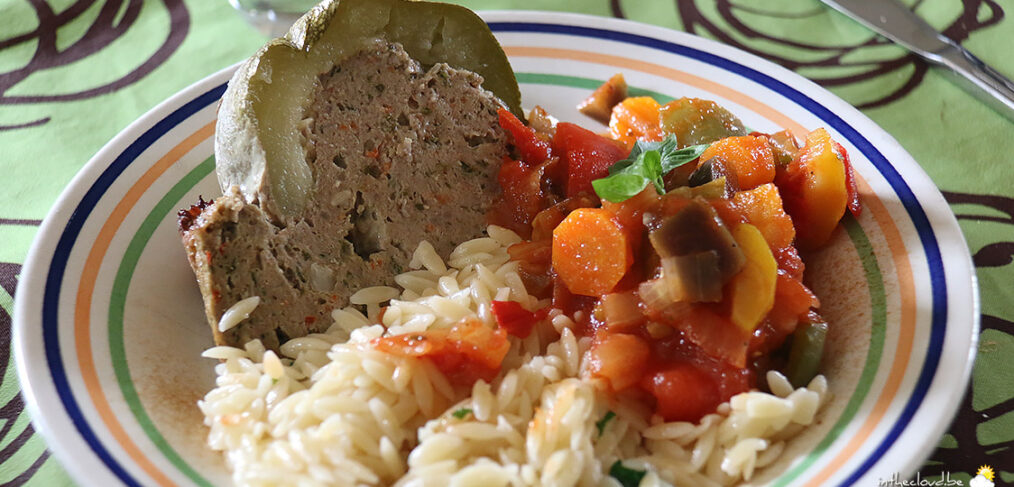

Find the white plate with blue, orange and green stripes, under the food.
xmin=15 ymin=12 xmax=979 ymax=486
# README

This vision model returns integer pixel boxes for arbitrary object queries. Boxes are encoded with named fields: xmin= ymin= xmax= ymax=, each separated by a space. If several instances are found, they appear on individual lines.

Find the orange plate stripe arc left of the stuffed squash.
xmin=74 ymin=122 xmax=215 ymax=486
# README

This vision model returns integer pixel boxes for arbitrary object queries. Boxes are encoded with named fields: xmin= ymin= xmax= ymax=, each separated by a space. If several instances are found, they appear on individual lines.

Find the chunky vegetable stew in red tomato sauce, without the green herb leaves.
xmin=373 ymin=99 xmax=858 ymax=421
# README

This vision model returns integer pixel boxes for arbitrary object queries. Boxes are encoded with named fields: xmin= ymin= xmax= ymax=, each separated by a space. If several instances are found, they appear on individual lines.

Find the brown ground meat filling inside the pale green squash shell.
xmin=180 ymin=40 xmax=506 ymax=350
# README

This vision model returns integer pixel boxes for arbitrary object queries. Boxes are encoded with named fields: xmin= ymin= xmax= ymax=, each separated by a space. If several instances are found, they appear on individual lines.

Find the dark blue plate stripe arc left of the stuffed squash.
xmin=43 ymin=83 xmax=225 ymax=486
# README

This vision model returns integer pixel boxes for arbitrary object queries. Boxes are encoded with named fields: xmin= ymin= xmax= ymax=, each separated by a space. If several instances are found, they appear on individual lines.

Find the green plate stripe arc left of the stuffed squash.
xmin=108 ymin=156 xmax=215 ymax=487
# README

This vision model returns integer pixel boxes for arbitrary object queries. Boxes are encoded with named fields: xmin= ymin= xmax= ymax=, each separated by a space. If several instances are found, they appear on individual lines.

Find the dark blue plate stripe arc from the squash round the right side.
xmin=490 ymin=22 xmax=947 ymax=486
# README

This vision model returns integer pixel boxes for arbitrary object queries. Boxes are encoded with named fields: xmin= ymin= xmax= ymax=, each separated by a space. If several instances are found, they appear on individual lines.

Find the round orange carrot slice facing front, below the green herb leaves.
xmin=553 ymin=208 xmax=634 ymax=296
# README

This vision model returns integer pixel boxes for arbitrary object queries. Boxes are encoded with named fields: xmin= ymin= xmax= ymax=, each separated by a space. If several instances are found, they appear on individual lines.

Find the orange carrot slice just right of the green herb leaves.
xmin=701 ymin=135 xmax=775 ymax=190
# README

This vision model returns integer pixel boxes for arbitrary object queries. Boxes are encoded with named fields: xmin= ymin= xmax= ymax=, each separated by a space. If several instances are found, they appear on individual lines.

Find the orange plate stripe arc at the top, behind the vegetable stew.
xmin=504 ymin=47 xmax=809 ymax=136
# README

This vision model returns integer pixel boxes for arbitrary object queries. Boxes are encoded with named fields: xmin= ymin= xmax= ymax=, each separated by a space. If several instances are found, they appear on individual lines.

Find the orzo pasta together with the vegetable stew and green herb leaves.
xmin=189 ymin=0 xmax=860 ymax=486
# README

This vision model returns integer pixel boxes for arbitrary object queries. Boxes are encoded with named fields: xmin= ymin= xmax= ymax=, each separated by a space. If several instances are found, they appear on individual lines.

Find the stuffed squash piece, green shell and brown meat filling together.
xmin=180 ymin=0 xmax=518 ymax=350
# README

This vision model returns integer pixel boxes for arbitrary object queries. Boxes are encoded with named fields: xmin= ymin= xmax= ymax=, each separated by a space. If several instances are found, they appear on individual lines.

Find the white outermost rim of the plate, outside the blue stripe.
xmin=12 ymin=10 xmax=981 ymax=487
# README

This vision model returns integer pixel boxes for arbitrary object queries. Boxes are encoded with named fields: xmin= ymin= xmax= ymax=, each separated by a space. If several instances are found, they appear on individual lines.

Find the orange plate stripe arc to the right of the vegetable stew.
xmin=807 ymin=175 xmax=916 ymax=485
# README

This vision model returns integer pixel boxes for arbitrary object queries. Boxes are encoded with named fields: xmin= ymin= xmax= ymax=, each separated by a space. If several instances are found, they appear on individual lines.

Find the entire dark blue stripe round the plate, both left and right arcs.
xmin=43 ymin=22 xmax=947 ymax=486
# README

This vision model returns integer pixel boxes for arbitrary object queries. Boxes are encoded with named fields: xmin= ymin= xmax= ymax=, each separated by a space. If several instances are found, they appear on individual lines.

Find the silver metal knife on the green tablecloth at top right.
xmin=821 ymin=0 xmax=1014 ymax=121
